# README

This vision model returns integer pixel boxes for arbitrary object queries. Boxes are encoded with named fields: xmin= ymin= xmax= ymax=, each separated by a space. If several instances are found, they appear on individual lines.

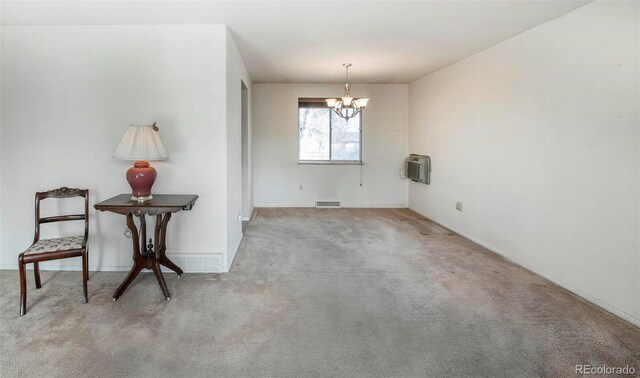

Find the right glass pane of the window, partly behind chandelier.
xmin=331 ymin=113 xmax=360 ymax=161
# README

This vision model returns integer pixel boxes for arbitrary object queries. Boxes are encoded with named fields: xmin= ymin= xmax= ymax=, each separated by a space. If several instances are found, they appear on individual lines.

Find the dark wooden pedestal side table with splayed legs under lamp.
xmin=93 ymin=194 xmax=198 ymax=301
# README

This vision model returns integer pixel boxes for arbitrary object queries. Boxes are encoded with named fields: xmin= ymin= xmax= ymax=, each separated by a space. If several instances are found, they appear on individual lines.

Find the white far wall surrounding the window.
xmin=252 ymin=84 xmax=408 ymax=207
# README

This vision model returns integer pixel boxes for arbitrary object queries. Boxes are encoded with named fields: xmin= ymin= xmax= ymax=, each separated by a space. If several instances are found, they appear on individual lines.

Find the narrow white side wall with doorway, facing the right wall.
xmin=222 ymin=29 xmax=251 ymax=271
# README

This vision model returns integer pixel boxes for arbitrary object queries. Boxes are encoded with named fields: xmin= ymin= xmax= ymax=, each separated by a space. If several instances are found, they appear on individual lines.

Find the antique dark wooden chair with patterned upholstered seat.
xmin=18 ymin=187 xmax=89 ymax=316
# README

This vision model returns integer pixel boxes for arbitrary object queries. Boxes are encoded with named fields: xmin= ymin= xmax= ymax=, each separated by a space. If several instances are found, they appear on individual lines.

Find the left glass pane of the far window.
xmin=299 ymin=108 xmax=330 ymax=160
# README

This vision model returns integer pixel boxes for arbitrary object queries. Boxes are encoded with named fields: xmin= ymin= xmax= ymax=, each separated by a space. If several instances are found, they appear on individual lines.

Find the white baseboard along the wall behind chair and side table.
xmin=0 ymin=253 xmax=228 ymax=273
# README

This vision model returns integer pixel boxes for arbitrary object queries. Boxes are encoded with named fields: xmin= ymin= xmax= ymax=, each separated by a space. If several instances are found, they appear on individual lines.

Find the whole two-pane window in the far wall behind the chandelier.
xmin=298 ymin=98 xmax=362 ymax=164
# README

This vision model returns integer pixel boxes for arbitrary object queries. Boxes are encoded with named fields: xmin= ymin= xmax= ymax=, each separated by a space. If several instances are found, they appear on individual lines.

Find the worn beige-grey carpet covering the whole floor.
xmin=0 ymin=209 xmax=640 ymax=377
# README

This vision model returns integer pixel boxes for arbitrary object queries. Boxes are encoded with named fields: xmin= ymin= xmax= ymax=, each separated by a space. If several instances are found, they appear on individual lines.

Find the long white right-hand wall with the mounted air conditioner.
xmin=409 ymin=2 xmax=640 ymax=325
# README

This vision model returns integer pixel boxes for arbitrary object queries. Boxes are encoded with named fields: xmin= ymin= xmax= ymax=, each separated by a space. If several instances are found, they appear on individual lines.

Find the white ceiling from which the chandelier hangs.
xmin=1 ymin=0 xmax=589 ymax=83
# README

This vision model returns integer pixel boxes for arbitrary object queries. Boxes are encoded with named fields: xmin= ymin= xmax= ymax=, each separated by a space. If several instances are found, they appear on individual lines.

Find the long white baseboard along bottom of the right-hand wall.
xmin=410 ymin=209 xmax=640 ymax=327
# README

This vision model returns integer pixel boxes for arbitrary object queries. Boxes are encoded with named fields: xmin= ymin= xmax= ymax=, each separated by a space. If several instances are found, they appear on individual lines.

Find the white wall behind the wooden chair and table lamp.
xmin=0 ymin=25 xmax=227 ymax=271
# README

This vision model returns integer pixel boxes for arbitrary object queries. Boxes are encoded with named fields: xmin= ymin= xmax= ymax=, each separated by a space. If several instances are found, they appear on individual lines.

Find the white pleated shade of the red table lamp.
xmin=113 ymin=125 xmax=169 ymax=160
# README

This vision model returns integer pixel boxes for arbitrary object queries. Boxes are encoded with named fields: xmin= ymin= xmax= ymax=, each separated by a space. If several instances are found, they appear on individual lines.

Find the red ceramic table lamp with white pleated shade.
xmin=113 ymin=122 xmax=168 ymax=202
